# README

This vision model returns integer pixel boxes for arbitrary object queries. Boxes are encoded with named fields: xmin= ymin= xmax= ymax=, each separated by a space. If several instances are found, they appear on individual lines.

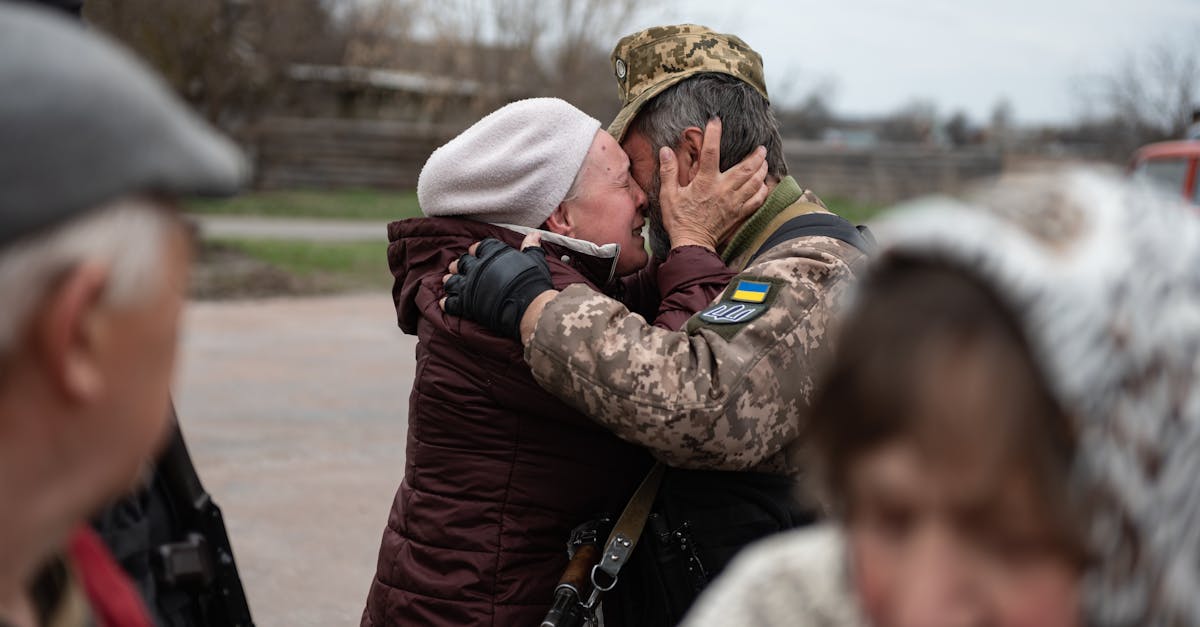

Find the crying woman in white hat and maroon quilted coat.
xmin=362 ymin=98 xmax=766 ymax=626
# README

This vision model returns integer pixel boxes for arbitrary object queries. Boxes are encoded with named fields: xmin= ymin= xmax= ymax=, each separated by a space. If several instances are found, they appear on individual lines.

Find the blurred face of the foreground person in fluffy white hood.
xmin=847 ymin=440 xmax=1080 ymax=627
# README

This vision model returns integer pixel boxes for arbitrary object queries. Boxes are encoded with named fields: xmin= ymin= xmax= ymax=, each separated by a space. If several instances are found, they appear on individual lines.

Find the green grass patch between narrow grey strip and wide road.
xmin=211 ymin=238 xmax=391 ymax=291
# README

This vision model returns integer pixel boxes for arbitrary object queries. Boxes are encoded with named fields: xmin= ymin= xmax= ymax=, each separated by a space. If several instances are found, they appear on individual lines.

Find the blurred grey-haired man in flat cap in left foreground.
xmin=0 ymin=2 xmax=247 ymax=627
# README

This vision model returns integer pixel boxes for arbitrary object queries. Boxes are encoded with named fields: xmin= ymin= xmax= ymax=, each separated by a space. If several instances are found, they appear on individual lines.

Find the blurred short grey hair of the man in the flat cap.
xmin=0 ymin=197 xmax=174 ymax=363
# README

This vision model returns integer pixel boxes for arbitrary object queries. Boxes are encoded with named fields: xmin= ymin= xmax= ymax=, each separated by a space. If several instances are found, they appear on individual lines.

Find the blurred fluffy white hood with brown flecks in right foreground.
xmin=876 ymin=171 xmax=1200 ymax=627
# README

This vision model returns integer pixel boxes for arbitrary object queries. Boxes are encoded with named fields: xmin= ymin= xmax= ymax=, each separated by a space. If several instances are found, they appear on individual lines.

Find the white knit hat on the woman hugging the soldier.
xmin=416 ymin=98 xmax=600 ymax=227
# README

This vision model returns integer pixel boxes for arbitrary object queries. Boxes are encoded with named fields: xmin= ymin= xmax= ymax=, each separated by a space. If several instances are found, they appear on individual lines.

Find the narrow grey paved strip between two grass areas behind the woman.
xmin=192 ymin=215 xmax=388 ymax=241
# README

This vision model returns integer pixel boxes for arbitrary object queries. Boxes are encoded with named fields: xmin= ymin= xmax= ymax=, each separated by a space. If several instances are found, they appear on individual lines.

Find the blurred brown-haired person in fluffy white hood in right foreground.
xmin=690 ymin=166 xmax=1200 ymax=627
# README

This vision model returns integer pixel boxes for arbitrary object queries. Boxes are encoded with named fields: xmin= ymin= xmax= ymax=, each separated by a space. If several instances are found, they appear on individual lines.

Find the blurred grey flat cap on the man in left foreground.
xmin=0 ymin=0 xmax=248 ymax=247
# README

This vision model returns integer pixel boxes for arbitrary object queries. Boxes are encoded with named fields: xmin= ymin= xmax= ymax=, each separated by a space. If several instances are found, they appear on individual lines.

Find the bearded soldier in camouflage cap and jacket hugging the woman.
xmin=451 ymin=25 xmax=865 ymax=476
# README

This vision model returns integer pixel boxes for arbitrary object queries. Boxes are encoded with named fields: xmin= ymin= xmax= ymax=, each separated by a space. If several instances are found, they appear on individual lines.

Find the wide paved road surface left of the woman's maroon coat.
xmin=175 ymin=293 xmax=415 ymax=627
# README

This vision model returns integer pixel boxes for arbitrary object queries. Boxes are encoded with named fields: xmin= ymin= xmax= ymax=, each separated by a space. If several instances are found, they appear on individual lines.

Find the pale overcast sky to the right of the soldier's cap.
xmin=634 ymin=0 xmax=1200 ymax=123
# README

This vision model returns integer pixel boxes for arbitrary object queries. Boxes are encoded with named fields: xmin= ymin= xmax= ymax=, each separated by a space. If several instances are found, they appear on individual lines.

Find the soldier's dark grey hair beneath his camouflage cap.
xmin=631 ymin=72 xmax=787 ymax=178
